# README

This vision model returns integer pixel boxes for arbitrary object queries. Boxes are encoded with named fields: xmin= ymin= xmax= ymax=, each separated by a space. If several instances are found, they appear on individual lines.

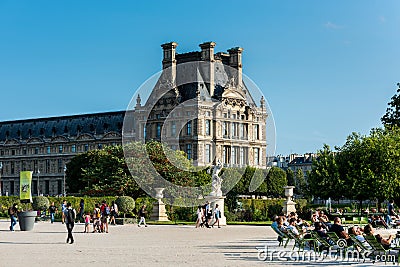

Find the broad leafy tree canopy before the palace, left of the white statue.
xmin=66 ymin=141 xmax=211 ymax=198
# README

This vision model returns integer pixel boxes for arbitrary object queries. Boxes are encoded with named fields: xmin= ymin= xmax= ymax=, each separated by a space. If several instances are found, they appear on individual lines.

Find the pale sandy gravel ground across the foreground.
xmin=0 ymin=221 xmax=396 ymax=267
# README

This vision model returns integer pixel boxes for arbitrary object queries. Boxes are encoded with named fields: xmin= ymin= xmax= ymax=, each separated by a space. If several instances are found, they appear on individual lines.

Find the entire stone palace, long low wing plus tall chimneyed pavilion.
xmin=0 ymin=42 xmax=267 ymax=195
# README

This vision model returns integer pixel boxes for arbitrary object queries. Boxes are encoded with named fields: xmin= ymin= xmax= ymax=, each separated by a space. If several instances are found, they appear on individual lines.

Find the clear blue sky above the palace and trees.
xmin=0 ymin=0 xmax=400 ymax=154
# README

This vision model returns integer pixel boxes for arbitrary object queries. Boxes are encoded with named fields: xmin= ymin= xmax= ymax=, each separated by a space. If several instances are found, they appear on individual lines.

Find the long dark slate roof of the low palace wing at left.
xmin=0 ymin=111 xmax=125 ymax=141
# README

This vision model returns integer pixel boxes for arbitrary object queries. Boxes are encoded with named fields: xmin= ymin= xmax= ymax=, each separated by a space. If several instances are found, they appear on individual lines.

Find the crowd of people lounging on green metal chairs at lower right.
xmin=271 ymin=211 xmax=395 ymax=252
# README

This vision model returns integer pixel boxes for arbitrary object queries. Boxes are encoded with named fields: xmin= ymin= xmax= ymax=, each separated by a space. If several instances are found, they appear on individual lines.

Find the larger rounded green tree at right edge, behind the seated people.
xmin=338 ymin=127 xmax=400 ymax=209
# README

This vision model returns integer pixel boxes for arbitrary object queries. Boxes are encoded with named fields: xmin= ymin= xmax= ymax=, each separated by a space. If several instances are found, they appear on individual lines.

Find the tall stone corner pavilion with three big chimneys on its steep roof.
xmin=132 ymin=42 xmax=267 ymax=168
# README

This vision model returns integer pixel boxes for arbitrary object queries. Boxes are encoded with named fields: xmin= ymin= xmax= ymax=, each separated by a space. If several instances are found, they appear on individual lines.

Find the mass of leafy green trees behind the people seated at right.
xmin=309 ymin=127 xmax=400 ymax=207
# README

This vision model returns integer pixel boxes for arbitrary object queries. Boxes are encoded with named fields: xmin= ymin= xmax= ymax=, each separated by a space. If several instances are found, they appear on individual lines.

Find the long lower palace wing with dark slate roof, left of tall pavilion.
xmin=0 ymin=111 xmax=125 ymax=195
